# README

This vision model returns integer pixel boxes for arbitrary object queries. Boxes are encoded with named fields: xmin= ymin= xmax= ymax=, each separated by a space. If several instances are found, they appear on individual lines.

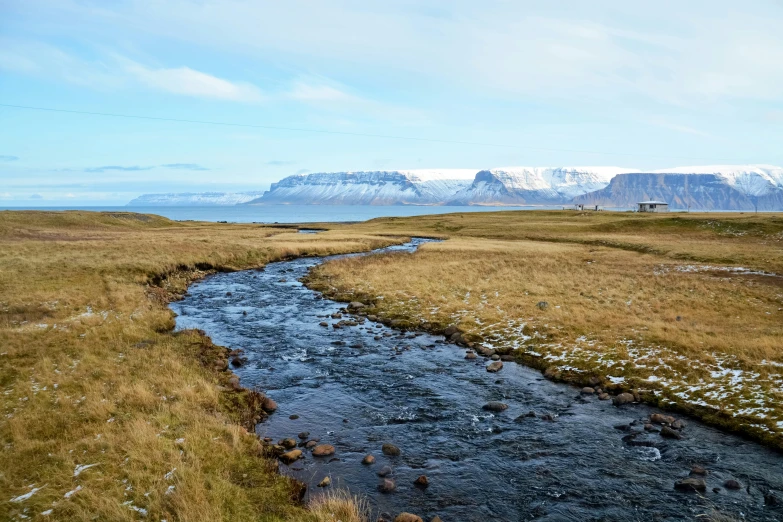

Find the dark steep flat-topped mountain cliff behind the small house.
xmin=574 ymin=169 xmax=783 ymax=211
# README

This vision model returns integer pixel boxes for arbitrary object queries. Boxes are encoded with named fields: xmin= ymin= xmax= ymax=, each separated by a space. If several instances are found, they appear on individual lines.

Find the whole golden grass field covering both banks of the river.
xmin=0 ymin=208 xmax=783 ymax=522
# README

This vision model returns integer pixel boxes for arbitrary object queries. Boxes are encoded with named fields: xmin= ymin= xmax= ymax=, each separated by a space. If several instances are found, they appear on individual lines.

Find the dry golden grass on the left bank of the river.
xmin=0 ymin=212 xmax=391 ymax=521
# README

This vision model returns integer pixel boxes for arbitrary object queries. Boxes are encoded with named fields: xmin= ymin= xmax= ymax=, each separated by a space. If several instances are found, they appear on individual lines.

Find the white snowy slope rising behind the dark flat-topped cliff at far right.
xmin=652 ymin=165 xmax=783 ymax=197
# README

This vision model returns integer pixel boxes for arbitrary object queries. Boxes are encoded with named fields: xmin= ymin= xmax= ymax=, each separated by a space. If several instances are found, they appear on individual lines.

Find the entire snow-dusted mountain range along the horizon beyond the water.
xmin=129 ymin=165 xmax=783 ymax=211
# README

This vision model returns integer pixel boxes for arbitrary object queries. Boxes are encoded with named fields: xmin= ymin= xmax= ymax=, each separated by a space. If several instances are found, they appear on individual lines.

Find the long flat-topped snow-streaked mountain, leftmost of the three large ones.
xmin=250 ymin=169 xmax=476 ymax=205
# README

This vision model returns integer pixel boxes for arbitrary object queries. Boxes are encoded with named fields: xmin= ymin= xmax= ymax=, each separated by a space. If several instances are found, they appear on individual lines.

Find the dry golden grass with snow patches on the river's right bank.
xmin=311 ymin=212 xmax=783 ymax=446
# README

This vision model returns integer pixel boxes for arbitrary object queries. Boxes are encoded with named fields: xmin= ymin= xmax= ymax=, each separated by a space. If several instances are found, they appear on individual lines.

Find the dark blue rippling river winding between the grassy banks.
xmin=171 ymin=239 xmax=783 ymax=522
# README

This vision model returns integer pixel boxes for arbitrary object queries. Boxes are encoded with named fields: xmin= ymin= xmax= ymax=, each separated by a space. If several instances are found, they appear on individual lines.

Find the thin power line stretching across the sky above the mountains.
xmin=0 ymin=103 xmax=743 ymax=163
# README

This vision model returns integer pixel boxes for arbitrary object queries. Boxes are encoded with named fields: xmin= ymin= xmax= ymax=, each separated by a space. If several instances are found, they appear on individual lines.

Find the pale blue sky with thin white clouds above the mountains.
xmin=0 ymin=0 xmax=783 ymax=207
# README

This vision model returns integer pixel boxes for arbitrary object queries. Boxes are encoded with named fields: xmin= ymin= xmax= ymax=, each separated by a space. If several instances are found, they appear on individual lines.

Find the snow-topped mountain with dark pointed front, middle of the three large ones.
xmin=450 ymin=167 xmax=638 ymax=205
